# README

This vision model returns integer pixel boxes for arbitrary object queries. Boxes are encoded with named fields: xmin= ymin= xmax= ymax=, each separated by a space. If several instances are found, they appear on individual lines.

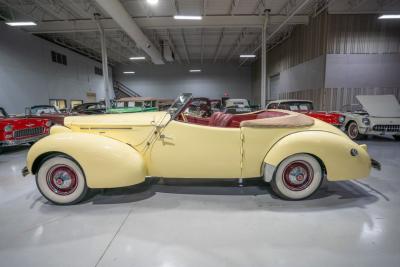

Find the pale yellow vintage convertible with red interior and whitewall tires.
xmin=23 ymin=94 xmax=380 ymax=204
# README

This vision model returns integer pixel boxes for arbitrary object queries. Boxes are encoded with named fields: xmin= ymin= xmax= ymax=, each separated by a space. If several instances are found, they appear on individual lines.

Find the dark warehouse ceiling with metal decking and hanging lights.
xmin=0 ymin=0 xmax=400 ymax=65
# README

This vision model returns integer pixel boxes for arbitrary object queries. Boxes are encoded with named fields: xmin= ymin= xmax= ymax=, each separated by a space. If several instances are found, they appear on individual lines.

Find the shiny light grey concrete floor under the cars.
xmin=0 ymin=138 xmax=400 ymax=267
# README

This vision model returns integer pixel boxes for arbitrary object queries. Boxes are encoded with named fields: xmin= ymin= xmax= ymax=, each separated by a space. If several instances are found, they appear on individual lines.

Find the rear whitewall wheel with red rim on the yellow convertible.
xmin=271 ymin=154 xmax=323 ymax=200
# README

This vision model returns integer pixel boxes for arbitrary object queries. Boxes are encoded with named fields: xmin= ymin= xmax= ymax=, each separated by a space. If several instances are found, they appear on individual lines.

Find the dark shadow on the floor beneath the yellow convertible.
xmin=84 ymin=179 xmax=380 ymax=211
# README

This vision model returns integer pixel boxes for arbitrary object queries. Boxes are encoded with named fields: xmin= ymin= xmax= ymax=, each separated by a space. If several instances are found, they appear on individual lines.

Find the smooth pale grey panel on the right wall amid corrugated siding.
xmin=325 ymin=54 xmax=400 ymax=88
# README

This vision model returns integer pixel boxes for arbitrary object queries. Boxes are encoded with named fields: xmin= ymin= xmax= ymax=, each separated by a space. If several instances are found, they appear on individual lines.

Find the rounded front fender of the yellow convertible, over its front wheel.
xmin=27 ymin=132 xmax=147 ymax=188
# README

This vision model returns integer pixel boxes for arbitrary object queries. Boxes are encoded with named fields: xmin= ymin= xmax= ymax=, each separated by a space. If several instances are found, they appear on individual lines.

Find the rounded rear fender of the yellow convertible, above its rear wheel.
xmin=264 ymin=131 xmax=371 ymax=181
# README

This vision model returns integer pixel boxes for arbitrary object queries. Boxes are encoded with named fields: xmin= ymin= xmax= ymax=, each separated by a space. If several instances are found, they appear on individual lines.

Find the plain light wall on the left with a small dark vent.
xmin=0 ymin=24 xmax=112 ymax=113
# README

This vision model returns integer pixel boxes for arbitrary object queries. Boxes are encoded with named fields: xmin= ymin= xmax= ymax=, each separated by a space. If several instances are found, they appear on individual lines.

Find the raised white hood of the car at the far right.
xmin=356 ymin=95 xmax=400 ymax=118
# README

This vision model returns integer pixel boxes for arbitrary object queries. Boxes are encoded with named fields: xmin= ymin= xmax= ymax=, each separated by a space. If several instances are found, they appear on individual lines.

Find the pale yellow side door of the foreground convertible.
xmin=146 ymin=121 xmax=241 ymax=178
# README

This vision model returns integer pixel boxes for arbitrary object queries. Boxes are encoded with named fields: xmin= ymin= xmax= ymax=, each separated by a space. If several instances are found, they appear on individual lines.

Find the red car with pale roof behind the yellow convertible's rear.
xmin=267 ymin=99 xmax=345 ymax=128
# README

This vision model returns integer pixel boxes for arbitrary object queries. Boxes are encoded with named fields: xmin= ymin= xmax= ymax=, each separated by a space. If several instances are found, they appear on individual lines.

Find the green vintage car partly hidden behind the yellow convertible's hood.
xmin=107 ymin=97 xmax=173 ymax=113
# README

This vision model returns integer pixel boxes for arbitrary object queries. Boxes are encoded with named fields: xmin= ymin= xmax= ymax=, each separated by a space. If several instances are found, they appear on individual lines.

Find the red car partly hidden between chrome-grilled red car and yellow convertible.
xmin=25 ymin=105 xmax=69 ymax=125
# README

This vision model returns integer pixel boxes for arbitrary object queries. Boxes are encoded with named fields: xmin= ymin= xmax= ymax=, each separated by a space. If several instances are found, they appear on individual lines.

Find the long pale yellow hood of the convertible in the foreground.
xmin=64 ymin=112 xmax=170 ymax=128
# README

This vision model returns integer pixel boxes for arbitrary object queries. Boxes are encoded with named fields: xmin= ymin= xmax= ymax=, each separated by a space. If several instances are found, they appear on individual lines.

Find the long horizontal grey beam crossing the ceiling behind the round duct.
xmin=26 ymin=15 xmax=308 ymax=33
